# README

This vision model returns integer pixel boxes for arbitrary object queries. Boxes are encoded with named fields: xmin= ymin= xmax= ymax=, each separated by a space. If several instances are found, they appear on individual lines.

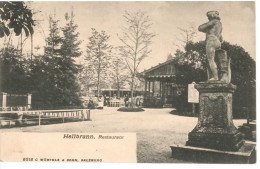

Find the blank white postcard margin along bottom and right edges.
xmin=0 ymin=0 xmax=260 ymax=169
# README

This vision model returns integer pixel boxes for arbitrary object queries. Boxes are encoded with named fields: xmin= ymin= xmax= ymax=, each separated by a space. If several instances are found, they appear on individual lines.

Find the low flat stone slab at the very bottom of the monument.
xmin=171 ymin=142 xmax=256 ymax=164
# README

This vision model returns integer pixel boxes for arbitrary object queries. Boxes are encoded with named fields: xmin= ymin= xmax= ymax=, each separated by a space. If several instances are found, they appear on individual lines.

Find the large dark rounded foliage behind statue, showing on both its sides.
xmin=176 ymin=41 xmax=256 ymax=118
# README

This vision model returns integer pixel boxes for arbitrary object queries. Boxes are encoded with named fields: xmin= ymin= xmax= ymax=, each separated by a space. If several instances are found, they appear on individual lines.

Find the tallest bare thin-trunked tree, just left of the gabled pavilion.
xmin=119 ymin=11 xmax=155 ymax=107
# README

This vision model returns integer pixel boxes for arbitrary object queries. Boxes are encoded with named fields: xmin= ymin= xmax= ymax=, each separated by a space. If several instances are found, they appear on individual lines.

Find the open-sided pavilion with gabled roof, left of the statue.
xmin=138 ymin=58 xmax=187 ymax=107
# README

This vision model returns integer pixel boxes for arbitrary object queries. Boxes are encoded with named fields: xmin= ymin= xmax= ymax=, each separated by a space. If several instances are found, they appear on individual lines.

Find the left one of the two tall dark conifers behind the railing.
xmin=31 ymin=15 xmax=62 ymax=109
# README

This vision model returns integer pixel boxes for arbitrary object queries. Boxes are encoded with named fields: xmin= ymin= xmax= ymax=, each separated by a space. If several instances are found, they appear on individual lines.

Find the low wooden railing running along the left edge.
xmin=0 ymin=109 xmax=90 ymax=126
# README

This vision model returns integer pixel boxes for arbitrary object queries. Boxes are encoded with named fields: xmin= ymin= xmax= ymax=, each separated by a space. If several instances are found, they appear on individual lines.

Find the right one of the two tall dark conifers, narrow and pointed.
xmin=58 ymin=11 xmax=82 ymax=106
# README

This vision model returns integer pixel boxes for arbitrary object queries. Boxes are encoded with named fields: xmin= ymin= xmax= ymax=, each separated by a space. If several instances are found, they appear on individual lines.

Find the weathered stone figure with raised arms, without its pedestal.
xmin=199 ymin=11 xmax=231 ymax=83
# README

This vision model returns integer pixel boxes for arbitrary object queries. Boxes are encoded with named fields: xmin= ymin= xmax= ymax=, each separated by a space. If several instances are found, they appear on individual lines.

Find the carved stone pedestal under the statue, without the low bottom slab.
xmin=186 ymin=82 xmax=244 ymax=151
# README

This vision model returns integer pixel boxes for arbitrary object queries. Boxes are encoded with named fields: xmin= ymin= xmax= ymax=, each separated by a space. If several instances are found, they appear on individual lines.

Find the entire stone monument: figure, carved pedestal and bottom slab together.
xmin=171 ymin=11 xmax=255 ymax=163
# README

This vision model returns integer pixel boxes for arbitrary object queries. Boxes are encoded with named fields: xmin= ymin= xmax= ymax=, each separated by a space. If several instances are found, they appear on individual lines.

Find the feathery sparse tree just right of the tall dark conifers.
xmin=85 ymin=28 xmax=112 ymax=96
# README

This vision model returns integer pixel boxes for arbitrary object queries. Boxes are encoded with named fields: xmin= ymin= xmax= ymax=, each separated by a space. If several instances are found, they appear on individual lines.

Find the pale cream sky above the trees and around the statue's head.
xmin=2 ymin=1 xmax=256 ymax=71
